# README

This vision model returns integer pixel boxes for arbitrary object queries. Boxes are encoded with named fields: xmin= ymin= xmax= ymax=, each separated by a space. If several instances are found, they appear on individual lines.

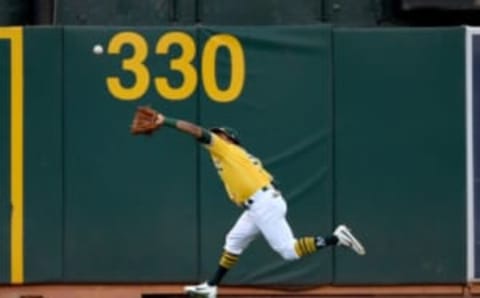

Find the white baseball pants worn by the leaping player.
xmin=224 ymin=188 xmax=299 ymax=260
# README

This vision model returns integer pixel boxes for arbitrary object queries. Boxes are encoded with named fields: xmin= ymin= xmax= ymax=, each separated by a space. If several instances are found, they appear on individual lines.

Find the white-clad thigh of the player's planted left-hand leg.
xmin=224 ymin=211 xmax=260 ymax=254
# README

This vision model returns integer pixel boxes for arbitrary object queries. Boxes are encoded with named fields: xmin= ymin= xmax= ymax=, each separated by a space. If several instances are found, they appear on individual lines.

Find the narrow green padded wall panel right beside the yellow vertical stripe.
xmin=24 ymin=28 xmax=64 ymax=283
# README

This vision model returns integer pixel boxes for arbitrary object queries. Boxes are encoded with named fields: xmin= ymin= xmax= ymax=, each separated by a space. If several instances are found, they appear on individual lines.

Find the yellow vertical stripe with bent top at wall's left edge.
xmin=0 ymin=27 xmax=24 ymax=284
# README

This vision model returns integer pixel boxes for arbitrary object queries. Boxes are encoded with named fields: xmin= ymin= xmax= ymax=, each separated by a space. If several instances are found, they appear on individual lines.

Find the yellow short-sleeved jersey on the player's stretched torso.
xmin=205 ymin=133 xmax=273 ymax=205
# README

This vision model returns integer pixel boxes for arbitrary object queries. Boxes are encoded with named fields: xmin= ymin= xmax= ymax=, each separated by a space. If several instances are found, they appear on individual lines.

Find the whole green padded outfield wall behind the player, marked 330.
xmin=0 ymin=25 xmax=466 ymax=285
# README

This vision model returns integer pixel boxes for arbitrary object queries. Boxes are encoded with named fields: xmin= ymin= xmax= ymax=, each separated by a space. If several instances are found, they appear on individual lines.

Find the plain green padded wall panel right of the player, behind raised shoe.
xmin=334 ymin=28 xmax=466 ymax=284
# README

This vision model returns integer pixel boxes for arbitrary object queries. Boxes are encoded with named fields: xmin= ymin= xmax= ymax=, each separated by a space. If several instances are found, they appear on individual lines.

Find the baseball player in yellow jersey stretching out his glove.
xmin=131 ymin=107 xmax=365 ymax=298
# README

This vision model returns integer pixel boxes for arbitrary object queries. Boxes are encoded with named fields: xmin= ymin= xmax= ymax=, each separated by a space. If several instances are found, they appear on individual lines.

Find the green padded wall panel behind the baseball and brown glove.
xmin=64 ymin=28 xmax=198 ymax=282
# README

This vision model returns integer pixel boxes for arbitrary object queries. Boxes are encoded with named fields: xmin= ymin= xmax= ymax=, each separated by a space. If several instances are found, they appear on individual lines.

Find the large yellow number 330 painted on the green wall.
xmin=106 ymin=31 xmax=245 ymax=102
